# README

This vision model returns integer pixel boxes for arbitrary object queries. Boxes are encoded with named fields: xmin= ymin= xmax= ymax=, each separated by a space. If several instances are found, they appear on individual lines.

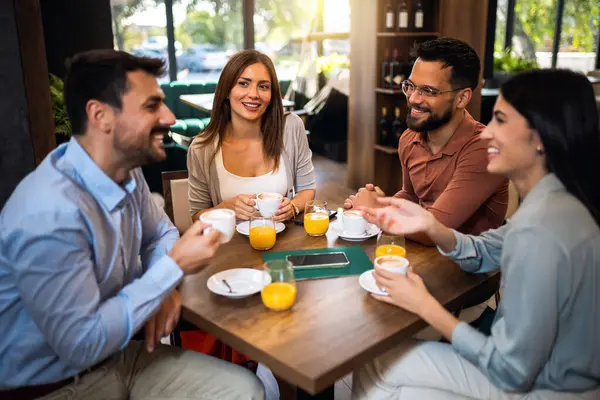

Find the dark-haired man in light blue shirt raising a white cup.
xmin=0 ymin=50 xmax=264 ymax=399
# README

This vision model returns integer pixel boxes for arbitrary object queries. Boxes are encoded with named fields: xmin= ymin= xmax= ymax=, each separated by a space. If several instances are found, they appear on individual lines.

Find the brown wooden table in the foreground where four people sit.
xmin=181 ymin=208 xmax=499 ymax=394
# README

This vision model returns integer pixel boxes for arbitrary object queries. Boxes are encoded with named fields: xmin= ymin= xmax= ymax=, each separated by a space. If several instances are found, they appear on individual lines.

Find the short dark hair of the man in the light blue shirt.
xmin=65 ymin=50 xmax=165 ymax=134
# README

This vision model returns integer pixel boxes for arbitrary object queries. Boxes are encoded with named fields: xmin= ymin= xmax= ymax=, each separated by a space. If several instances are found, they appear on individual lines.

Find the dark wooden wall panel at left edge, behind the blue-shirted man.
xmin=0 ymin=0 xmax=55 ymax=208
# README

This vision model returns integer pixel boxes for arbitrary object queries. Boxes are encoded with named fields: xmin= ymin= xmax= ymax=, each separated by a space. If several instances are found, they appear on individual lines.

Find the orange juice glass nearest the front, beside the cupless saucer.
xmin=260 ymin=260 xmax=296 ymax=311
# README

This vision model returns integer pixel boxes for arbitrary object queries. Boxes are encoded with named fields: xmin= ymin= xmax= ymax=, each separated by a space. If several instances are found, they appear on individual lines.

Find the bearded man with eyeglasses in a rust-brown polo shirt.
xmin=344 ymin=38 xmax=508 ymax=245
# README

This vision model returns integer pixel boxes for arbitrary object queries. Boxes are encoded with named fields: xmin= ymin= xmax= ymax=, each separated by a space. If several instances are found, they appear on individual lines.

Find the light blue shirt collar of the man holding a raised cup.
xmin=63 ymin=137 xmax=136 ymax=212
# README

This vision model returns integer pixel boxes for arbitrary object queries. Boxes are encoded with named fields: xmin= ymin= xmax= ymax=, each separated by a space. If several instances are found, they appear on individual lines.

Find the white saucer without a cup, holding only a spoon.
xmin=206 ymin=268 xmax=271 ymax=299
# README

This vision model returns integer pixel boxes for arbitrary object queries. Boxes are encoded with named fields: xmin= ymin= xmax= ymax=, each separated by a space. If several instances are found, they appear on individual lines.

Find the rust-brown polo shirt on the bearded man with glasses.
xmin=395 ymin=111 xmax=508 ymax=244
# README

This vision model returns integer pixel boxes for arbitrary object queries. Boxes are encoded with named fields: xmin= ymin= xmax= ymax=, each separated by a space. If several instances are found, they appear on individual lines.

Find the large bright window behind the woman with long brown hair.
xmin=110 ymin=0 xmax=350 ymax=82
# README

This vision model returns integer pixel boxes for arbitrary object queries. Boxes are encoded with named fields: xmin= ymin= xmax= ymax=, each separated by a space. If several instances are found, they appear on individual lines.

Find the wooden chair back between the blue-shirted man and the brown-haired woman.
xmin=162 ymin=171 xmax=192 ymax=234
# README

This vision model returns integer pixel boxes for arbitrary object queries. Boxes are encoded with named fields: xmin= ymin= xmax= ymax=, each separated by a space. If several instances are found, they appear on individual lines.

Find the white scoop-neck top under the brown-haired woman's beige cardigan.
xmin=215 ymin=150 xmax=288 ymax=200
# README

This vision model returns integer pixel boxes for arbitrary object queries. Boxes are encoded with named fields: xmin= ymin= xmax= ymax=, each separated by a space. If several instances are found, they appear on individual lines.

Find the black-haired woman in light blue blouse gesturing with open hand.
xmin=353 ymin=70 xmax=600 ymax=399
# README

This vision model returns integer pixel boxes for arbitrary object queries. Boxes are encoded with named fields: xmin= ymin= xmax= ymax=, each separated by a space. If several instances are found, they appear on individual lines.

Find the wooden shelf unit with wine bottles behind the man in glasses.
xmin=347 ymin=0 xmax=495 ymax=193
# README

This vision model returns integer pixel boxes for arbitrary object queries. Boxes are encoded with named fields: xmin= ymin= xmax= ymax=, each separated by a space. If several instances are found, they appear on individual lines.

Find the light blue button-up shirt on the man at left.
xmin=0 ymin=139 xmax=183 ymax=390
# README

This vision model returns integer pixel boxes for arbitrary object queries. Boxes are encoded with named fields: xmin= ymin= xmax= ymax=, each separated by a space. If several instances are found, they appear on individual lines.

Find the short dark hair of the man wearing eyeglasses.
xmin=415 ymin=38 xmax=481 ymax=90
